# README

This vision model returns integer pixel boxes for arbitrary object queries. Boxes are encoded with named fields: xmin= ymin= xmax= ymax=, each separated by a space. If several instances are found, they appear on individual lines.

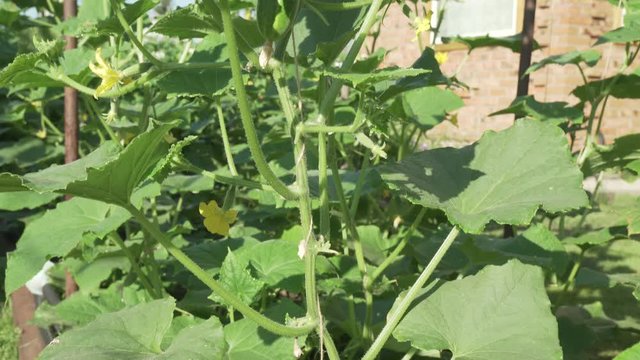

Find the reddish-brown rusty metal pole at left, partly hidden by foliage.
xmin=64 ymin=0 xmax=78 ymax=297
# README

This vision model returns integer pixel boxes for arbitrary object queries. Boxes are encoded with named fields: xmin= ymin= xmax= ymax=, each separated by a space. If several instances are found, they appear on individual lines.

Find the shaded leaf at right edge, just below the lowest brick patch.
xmin=582 ymin=133 xmax=640 ymax=176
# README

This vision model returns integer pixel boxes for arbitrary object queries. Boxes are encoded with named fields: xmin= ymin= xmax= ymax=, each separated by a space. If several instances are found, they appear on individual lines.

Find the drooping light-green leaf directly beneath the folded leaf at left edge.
xmin=5 ymin=198 xmax=130 ymax=293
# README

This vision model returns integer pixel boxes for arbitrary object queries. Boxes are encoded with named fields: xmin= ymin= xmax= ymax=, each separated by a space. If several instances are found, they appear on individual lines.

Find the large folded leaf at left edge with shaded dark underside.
xmin=0 ymin=123 xmax=175 ymax=205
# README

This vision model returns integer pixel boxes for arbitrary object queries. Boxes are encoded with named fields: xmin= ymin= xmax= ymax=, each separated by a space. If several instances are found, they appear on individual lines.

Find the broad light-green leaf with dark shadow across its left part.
xmin=378 ymin=120 xmax=588 ymax=233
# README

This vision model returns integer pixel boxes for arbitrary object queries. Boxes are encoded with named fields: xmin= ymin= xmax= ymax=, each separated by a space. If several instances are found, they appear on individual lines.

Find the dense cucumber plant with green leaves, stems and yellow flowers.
xmin=0 ymin=0 xmax=640 ymax=360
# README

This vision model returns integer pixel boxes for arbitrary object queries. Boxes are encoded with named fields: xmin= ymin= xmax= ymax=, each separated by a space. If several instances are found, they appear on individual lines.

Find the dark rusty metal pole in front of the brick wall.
xmin=502 ymin=0 xmax=536 ymax=239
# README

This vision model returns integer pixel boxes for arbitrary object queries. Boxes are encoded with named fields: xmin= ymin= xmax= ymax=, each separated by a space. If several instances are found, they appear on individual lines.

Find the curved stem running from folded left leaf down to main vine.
xmin=125 ymin=205 xmax=317 ymax=337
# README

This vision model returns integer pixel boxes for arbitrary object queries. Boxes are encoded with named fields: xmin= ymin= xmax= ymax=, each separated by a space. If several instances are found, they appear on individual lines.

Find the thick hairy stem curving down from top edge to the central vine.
xmin=219 ymin=0 xmax=299 ymax=200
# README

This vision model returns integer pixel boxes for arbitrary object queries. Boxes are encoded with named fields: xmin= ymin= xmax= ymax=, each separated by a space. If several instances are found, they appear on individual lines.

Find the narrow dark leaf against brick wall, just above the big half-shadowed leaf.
xmin=489 ymin=95 xmax=584 ymax=125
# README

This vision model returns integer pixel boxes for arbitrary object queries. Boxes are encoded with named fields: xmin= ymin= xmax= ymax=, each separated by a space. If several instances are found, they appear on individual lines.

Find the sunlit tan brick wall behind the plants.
xmin=377 ymin=0 xmax=640 ymax=146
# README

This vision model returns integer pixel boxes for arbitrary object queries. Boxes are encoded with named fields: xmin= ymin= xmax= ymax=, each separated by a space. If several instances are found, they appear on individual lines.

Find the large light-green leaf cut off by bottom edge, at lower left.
xmin=40 ymin=298 xmax=226 ymax=360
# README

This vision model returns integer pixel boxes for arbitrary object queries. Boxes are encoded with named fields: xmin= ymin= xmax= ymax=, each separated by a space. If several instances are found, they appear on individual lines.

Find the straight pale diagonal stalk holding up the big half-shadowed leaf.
xmin=362 ymin=226 xmax=460 ymax=360
